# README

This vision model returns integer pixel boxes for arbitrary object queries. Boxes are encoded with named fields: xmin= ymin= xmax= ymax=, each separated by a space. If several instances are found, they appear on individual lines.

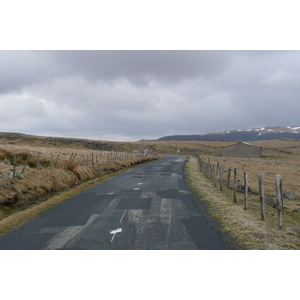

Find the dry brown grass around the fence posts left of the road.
xmin=0 ymin=144 xmax=158 ymax=220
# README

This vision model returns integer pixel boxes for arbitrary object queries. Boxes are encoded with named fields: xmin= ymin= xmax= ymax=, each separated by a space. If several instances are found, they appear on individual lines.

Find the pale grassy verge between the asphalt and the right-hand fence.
xmin=186 ymin=157 xmax=300 ymax=250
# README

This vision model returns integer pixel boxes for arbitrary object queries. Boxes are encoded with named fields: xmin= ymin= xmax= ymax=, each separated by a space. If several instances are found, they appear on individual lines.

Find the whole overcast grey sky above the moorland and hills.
xmin=0 ymin=50 xmax=300 ymax=141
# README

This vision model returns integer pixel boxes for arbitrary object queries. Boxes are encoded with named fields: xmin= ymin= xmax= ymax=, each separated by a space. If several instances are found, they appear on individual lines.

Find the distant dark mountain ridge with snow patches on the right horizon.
xmin=158 ymin=126 xmax=300 ymax=141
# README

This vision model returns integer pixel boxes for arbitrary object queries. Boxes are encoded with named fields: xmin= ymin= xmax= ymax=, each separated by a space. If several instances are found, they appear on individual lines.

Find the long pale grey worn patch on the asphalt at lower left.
xmin=46 ymin=214 xmax=99 ymax=250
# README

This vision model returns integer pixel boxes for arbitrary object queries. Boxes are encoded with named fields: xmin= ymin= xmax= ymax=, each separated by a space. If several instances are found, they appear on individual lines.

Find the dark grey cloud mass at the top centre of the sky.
xmin=52 ymin=51 xmax=229 ymax=84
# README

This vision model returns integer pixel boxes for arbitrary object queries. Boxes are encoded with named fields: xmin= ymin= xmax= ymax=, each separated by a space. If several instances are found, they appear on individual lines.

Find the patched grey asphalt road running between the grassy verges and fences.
xmin=0 ymin=156 xmax=237 ymax=250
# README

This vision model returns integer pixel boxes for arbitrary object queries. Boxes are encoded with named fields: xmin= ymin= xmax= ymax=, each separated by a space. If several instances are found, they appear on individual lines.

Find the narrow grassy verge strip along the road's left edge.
xmin=0 ymin=167 xmax=146 ymax=235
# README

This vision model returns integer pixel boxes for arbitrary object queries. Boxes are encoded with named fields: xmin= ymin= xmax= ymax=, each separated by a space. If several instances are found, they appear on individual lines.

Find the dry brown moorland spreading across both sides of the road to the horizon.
xmin=0 ymin=133 xmax=300 ymax=249
